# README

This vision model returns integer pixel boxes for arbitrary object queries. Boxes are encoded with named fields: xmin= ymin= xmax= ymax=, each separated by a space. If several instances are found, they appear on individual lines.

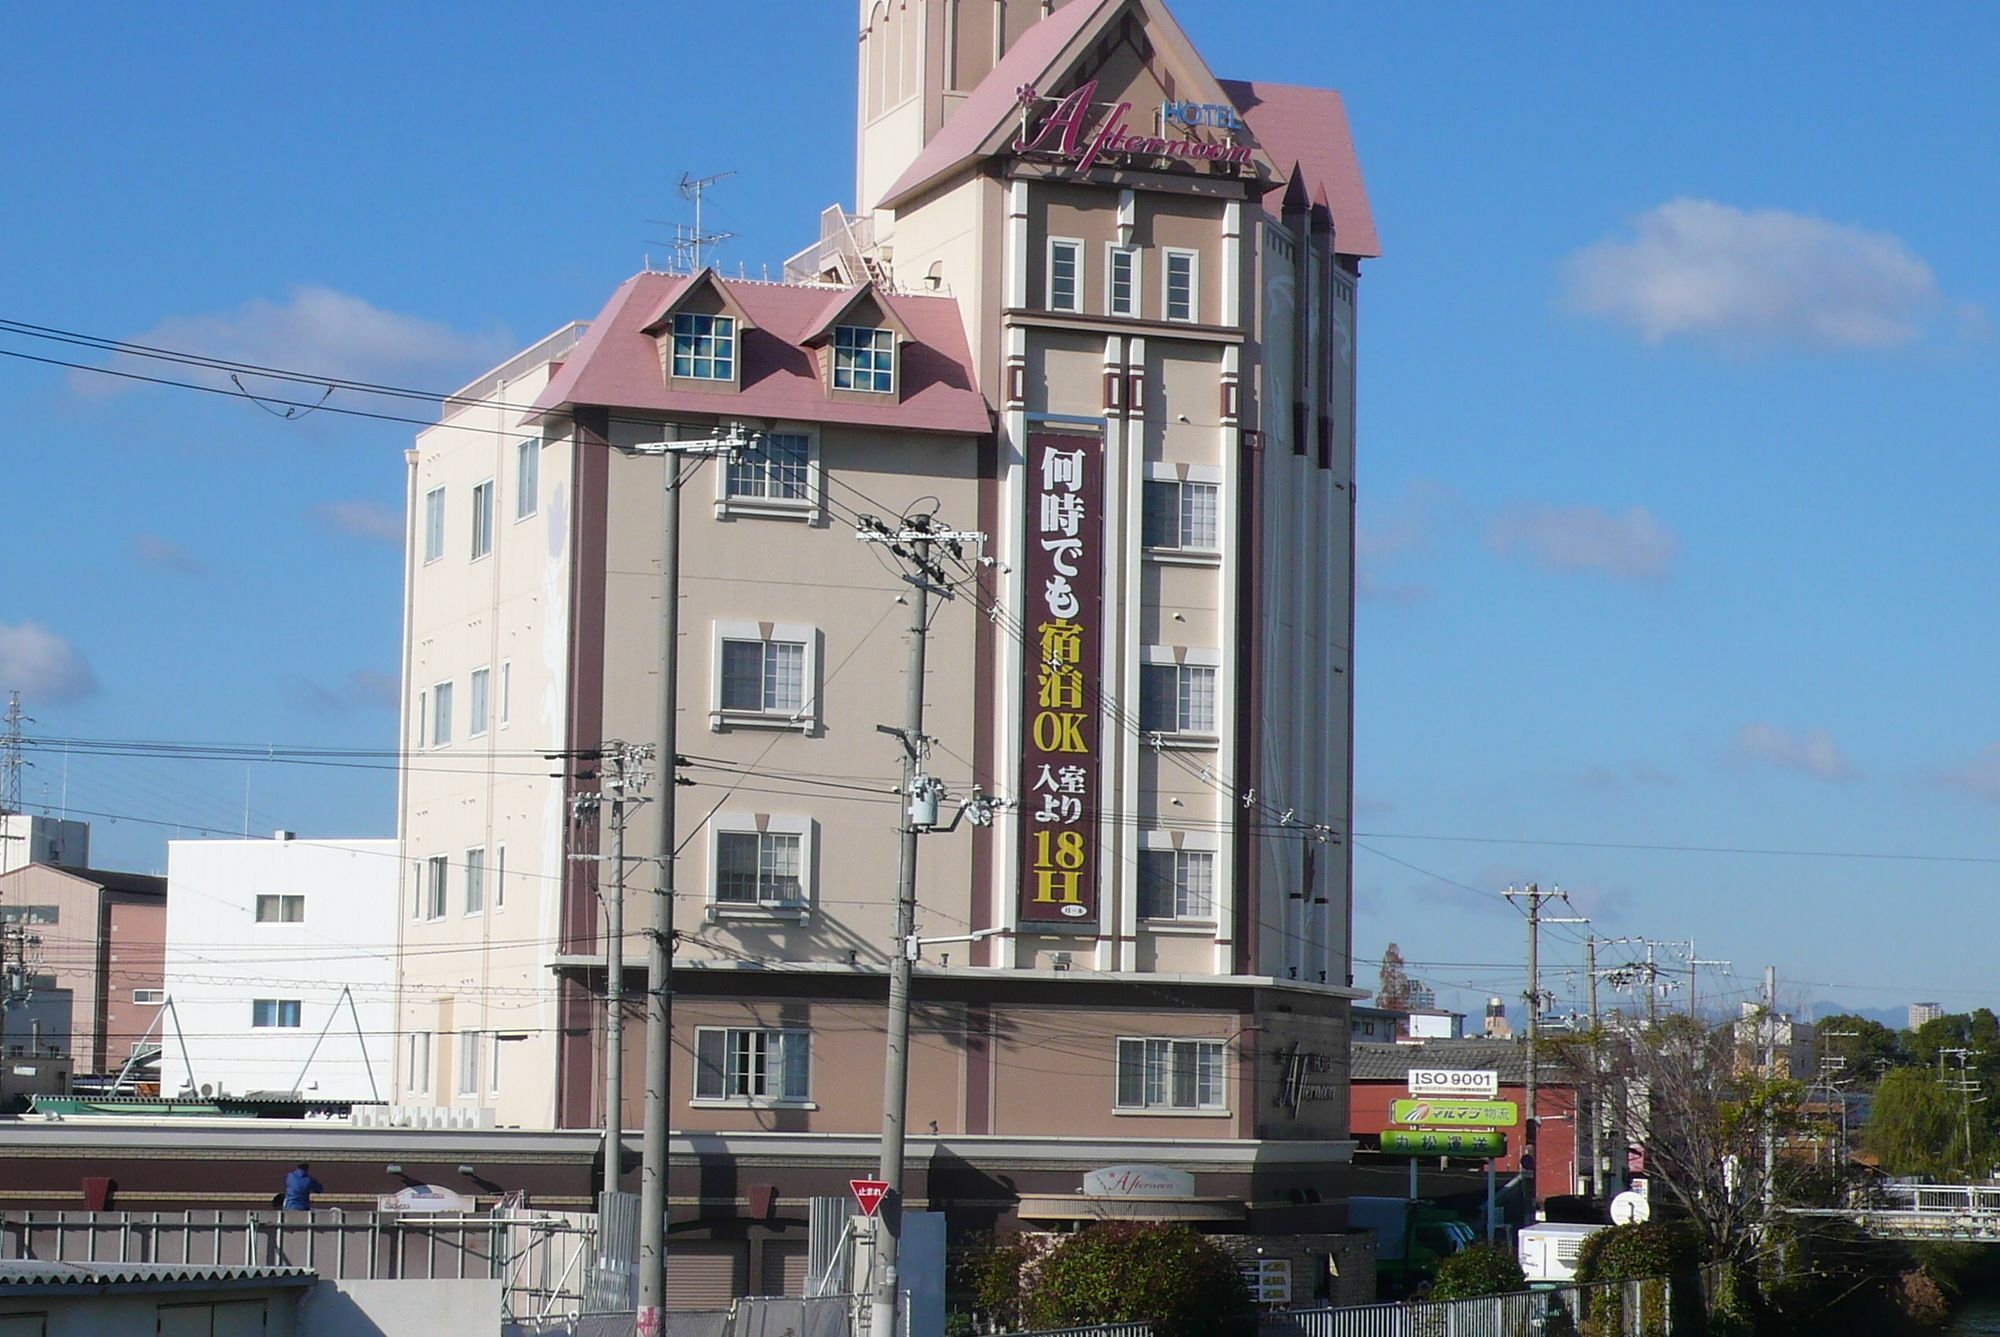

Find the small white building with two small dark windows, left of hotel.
xmin=160 ymin=831 xmax=396 ymax=1101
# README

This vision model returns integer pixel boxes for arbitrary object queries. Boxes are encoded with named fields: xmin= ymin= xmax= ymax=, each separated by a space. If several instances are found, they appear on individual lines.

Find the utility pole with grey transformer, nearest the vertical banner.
xmin=856 ymin=514 xmax=984 ymax=1337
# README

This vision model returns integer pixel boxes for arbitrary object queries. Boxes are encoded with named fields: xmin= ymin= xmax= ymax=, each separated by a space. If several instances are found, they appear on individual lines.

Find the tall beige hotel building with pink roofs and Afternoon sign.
xmin=396 ymin=0 xmax=1376 ymax=1289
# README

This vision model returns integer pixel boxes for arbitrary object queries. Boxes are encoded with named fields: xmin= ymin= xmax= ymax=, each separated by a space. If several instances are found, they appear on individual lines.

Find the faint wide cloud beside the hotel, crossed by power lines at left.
xmin=70 ymin=284 xmax=510 ymax=400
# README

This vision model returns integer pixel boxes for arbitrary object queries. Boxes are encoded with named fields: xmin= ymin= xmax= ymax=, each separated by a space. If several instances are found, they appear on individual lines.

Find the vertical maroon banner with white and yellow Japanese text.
xmin=1020 ymin=432 xmax=1104 ymax=933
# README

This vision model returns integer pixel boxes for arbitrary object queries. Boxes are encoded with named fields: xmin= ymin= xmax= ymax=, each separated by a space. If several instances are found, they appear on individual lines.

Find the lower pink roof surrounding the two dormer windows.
xmin=528 ymin=274 xmax=992 ymax=436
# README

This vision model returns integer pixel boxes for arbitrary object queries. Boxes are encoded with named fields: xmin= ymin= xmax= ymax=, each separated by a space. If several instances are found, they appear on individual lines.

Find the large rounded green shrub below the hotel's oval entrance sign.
xmin=1020 ymin=1225 xmax=1256 ymax=1337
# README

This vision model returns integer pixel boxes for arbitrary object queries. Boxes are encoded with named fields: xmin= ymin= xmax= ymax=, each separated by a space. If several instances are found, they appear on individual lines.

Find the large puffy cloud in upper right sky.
xmin=1562 ymin=200 xmax=1952 ymax=348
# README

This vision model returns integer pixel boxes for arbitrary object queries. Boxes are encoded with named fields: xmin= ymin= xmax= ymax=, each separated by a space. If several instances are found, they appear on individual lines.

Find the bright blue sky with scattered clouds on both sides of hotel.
xmin=0 ymin=0 xmax=2000 ymax=1013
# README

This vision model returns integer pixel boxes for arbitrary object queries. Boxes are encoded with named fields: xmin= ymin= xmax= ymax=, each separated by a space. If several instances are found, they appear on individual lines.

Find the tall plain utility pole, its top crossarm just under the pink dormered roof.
xmin=626 ymin=426 xmax=752 ymax=1337
